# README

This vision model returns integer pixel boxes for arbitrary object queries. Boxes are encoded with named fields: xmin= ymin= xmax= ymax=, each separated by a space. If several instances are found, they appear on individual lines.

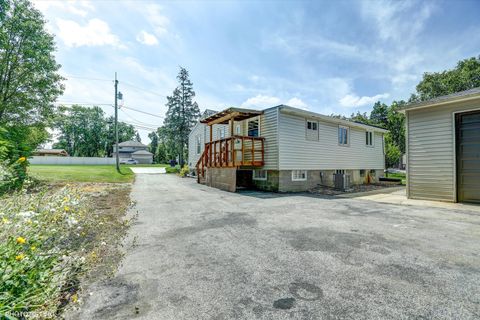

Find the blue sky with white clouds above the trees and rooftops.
xmin=34 ymin=0 xmax=480 ymax=142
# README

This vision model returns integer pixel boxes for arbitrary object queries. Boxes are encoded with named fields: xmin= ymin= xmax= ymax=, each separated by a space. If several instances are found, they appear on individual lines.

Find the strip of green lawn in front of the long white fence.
xmin=28 ymin=165 xmax=134 ymax=182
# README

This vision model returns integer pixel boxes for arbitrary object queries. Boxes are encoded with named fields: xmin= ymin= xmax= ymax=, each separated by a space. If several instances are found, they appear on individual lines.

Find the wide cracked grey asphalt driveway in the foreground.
xmin=70 ymin=174 xmax=480 ymax=319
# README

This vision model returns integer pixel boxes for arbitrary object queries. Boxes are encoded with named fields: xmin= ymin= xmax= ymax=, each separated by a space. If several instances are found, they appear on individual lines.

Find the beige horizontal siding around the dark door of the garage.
xmin=407 ymin=102 xmax=480 ymax=201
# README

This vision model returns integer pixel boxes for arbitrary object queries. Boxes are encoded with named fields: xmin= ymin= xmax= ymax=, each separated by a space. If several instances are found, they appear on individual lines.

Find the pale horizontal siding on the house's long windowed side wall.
xmin=279 ymin=112 xmax=385 ymax=170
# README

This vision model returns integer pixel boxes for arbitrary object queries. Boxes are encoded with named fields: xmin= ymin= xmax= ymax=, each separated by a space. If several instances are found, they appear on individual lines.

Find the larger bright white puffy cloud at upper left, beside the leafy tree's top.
xmin=57 ymin=18 xmax=123 ymax=47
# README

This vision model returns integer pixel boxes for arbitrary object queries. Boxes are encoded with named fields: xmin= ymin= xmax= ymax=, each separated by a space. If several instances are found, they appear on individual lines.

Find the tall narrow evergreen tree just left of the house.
xmin=165 ymin=67 xmax=200 ymax=166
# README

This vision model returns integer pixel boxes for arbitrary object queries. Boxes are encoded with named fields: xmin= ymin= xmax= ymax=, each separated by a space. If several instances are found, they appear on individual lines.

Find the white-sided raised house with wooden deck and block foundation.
xmin=189 ymin=105 xmax=387 ymax=192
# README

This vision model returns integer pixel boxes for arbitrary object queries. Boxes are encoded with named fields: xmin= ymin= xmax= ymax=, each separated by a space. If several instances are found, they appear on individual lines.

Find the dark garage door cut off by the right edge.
xmin=456 ymin=111 xmax=480 ymax=203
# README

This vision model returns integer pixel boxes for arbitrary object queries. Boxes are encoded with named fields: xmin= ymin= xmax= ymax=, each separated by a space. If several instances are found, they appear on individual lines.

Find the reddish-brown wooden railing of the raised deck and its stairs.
xmin=196 ymin=136 xmax=265 ymax=180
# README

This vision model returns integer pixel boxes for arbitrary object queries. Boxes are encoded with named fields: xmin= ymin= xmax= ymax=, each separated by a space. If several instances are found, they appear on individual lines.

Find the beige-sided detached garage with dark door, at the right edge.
xmin=403 ymin=87 xmax=480 ymax=203
